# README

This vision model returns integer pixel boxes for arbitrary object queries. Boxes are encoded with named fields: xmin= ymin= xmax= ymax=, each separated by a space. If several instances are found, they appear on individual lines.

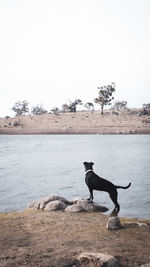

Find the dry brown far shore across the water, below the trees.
xmin=0 ymin=110 xmax=150 ymax=135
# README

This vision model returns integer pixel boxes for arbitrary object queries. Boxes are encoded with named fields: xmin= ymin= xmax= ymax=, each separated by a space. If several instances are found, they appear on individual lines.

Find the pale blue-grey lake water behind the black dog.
xmin=0 ymin=135 xmax=150 ymax=219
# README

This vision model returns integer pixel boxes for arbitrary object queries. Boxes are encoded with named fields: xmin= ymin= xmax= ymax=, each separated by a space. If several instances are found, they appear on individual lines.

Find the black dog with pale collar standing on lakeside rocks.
xmin=83 ymin=162 xmax=131 ymax=213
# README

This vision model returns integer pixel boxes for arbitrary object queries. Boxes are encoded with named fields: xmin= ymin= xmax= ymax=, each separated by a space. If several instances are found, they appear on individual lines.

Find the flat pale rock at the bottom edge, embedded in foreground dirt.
xmin=78 ymin=252 xmax=119 ymax=267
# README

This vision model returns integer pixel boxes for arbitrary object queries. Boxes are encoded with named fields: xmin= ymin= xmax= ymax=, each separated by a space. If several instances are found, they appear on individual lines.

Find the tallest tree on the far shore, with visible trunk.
xmin=94 ymin=83 xmax=115 ymax=114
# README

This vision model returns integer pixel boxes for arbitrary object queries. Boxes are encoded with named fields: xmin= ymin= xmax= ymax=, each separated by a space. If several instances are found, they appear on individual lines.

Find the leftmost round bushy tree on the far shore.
xmin=12 ymin=100 xmax=29 ymax=116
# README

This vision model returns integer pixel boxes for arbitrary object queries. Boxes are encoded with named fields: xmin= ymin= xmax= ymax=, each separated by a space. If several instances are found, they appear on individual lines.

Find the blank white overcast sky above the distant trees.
xmin=0 ymin=0 xmax=150 ymax=117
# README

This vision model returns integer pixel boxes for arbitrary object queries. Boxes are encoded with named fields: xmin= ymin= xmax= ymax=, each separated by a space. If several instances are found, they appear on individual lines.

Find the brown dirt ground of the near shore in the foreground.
xmin=0 ymin=209 xmax=150 ymax=267
